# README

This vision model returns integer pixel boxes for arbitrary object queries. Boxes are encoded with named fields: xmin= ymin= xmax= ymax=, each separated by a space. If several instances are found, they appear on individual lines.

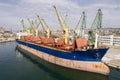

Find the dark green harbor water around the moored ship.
xmin=0 ymin=42 xmax=120 ymax=80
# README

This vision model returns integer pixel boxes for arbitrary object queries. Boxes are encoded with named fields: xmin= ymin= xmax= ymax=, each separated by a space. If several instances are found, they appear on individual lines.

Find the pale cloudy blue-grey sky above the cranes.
xmin=0 ymin=0 xmax=120 ymax=30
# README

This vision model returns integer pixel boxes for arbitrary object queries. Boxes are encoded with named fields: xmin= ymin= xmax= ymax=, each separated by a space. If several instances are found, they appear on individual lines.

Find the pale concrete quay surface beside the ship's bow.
xmin=102 ymin=46 xmax=120 ymax=69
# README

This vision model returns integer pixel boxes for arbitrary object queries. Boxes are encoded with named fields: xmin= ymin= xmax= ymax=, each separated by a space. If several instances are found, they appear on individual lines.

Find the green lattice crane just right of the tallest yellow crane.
xmin=74 ymin=12 xmax=86 ymax=38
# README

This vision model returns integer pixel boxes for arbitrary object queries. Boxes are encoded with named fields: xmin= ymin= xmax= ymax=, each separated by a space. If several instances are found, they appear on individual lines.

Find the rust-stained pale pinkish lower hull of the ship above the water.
xmin=18 ymin=44 xmax=110 ymax=75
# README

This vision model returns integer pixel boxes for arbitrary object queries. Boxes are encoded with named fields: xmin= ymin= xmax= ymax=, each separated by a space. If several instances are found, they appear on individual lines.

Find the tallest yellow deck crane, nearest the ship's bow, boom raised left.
xmin=53 ymin=5 xmax=68 ymax=44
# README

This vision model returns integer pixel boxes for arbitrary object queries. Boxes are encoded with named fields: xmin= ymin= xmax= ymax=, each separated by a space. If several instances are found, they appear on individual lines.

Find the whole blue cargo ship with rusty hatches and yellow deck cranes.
xmin=16 ymin=6 xmax=110 ymax=75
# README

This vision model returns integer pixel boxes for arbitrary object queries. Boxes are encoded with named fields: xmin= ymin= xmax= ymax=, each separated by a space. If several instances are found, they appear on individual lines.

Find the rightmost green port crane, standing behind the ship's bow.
xmin=88 ymin=9 xmax=102 ymax=48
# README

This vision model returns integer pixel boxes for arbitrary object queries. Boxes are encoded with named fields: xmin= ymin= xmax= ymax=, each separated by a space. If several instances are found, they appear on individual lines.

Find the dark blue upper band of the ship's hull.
xmin=17 ymin=40 xmax=108 ymax=62
